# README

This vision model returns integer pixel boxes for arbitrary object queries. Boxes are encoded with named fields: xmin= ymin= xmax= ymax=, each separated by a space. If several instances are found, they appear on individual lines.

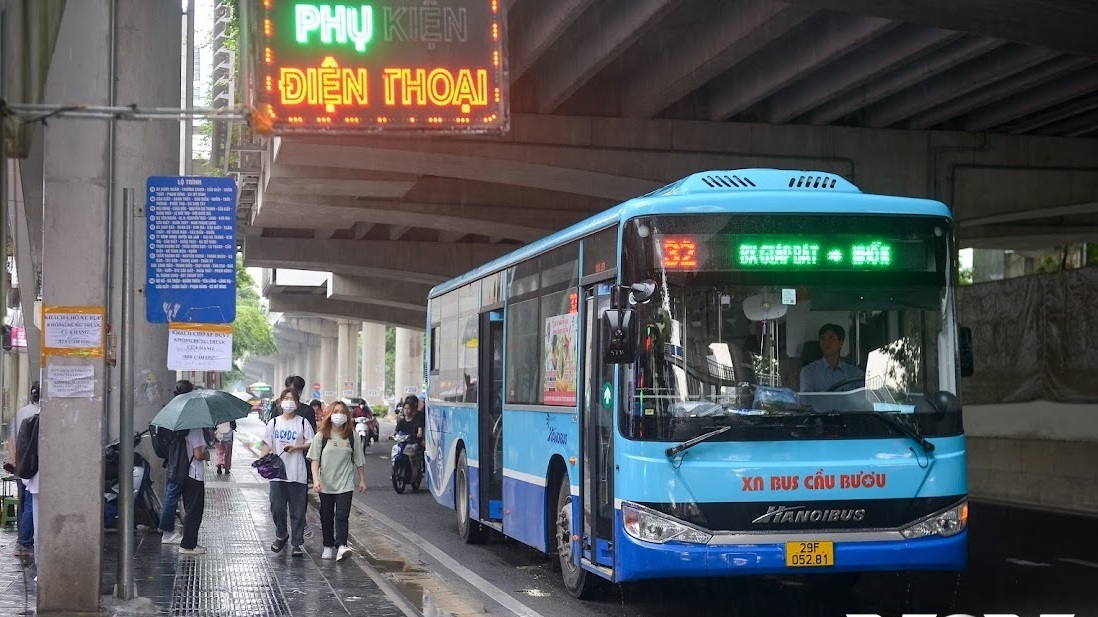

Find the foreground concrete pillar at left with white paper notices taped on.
xmin=35 ymin=13 xmax=111 ymax=613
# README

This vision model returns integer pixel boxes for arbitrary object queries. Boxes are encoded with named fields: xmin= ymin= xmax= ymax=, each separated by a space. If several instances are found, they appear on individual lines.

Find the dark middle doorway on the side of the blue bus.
xmin=477 ymin=311 xmax=503 ymax=524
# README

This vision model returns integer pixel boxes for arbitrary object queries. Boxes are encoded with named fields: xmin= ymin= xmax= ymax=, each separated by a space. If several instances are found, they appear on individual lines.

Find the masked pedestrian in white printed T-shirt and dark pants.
xmin=261 ymin=388 xmax=314 ymax=556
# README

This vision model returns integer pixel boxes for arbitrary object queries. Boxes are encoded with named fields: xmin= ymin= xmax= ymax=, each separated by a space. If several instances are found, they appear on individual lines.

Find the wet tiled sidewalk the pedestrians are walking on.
xmin=0 ymin=433 xmax=419 ymax=617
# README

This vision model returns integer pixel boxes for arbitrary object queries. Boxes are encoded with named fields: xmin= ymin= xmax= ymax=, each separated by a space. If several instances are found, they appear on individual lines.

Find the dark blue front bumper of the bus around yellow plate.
xmin=614 ymin=529 xmax=968 ymax=582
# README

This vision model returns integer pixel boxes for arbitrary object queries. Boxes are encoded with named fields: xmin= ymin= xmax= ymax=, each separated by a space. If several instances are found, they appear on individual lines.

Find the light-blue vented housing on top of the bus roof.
xmin=651 ymin=169 xmax=861 ymax=197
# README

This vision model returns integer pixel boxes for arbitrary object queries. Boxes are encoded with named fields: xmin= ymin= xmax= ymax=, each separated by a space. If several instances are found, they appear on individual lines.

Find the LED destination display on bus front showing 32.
xmin=656 ymin=234 xmax=934 ymax=272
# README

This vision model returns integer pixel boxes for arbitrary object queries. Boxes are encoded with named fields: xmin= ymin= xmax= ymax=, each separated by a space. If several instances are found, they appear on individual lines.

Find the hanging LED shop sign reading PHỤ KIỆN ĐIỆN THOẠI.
xmin=256 ymin=0 xmax=508 ymax=133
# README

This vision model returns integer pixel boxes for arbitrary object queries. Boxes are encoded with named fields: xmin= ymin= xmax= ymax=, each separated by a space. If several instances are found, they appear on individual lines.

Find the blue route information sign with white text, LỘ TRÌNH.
xmin=145 ymin=176 xmax=236 ymax=324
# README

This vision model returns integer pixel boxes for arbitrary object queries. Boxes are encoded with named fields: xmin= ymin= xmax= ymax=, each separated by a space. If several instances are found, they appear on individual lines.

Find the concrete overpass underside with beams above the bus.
xmin=240 ymin=0 xmax=1098 ymax=327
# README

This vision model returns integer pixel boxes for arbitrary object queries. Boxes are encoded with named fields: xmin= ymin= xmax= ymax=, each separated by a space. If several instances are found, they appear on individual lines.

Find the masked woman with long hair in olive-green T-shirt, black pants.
xmin=309 ymin=401 xmax=366 ymax=561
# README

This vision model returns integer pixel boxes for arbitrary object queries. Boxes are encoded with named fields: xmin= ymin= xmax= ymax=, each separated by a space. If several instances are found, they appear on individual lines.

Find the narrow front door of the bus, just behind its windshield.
xmin=580 ymin=283 xmax=616 ymax=566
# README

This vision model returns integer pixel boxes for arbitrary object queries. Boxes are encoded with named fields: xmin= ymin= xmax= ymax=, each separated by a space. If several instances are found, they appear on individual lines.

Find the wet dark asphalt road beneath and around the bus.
xmin=247 ymin=412 xmax=1098 ymax=617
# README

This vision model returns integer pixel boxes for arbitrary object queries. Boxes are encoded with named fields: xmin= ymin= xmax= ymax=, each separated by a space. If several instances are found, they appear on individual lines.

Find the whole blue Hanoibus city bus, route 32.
xmin=426 ymin=169 xmax=972 ymax=598
